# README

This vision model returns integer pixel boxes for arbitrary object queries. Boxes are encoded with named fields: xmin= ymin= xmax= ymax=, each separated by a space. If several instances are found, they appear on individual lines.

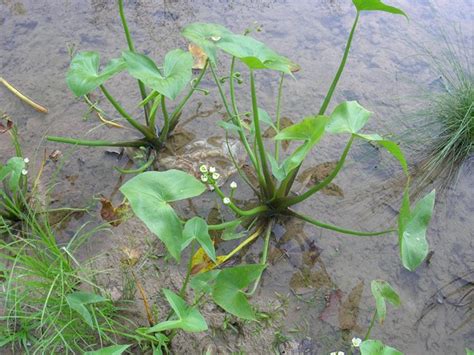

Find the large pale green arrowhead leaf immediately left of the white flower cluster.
xmin=120 ymin=170 xmax=206 ymax=261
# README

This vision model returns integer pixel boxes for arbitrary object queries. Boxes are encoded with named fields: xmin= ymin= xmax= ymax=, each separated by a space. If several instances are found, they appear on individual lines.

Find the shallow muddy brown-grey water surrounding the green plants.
xmin=0 ymin=0 xmax=474 ymax=354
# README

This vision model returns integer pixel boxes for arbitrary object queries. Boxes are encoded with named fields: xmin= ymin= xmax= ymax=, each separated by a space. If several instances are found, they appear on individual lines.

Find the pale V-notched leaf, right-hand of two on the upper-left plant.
xmin=122 ymin=49 xmax=193 ymax=100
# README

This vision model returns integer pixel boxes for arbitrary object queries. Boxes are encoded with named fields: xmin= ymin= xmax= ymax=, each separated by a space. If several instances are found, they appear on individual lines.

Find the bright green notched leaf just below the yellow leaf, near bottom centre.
xmin=212 ymin=264 xmax=265 ymax=320
